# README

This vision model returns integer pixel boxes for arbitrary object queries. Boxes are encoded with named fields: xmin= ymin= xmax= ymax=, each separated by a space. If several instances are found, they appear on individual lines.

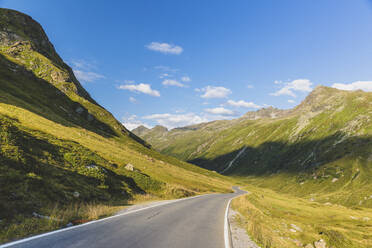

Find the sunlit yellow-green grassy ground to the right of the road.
xmin=232 ymin=186 xmax=372 ymax=248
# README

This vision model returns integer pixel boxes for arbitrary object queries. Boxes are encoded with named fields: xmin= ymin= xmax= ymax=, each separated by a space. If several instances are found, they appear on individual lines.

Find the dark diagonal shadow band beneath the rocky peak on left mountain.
xmin=0 ymin=54 xmax=117 ymax=137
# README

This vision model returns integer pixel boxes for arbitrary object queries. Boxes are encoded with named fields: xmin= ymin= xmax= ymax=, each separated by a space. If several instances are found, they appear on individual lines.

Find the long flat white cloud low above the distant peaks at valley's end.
xmin=143 ymin=113 xmax=209 ymax=129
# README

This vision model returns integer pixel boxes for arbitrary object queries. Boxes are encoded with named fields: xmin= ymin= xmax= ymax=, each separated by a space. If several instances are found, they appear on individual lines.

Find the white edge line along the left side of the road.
xmin=0 ymin=194 xmax=206 ymax=248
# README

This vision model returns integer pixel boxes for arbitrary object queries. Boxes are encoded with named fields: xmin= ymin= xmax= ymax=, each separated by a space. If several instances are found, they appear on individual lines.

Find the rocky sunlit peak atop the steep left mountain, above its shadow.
xmin=0 ymin=8 xmax=97 ymax=104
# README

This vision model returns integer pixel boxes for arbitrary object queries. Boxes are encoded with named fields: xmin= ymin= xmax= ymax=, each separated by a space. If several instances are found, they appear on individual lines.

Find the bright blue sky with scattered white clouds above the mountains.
xmin=0 ymin=0 xmax=372 ymax=129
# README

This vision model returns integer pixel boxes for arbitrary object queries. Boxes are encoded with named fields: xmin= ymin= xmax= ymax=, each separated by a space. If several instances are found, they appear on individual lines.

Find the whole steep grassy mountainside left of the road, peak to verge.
xmin=0 ymin=9 xmax=230 ymax=242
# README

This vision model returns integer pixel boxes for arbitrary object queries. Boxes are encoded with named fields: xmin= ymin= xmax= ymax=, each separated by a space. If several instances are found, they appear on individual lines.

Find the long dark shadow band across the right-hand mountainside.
xmin=188 ymin=132 xmax=372 ymax=176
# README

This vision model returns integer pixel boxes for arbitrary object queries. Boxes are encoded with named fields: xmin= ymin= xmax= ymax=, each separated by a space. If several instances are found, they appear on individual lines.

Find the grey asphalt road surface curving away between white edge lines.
xmin=0 ymin=188 xmax=245 ymax=248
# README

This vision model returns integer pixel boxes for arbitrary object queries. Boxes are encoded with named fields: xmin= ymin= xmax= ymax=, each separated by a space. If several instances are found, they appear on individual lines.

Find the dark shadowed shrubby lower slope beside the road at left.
xmin=0 ymin=116 xmax=144 ymax=219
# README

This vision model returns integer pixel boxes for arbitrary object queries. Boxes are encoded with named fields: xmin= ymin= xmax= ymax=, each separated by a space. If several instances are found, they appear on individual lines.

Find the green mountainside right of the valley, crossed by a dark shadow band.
xmin=134 ymin=86 xmax=372 ymax=207
